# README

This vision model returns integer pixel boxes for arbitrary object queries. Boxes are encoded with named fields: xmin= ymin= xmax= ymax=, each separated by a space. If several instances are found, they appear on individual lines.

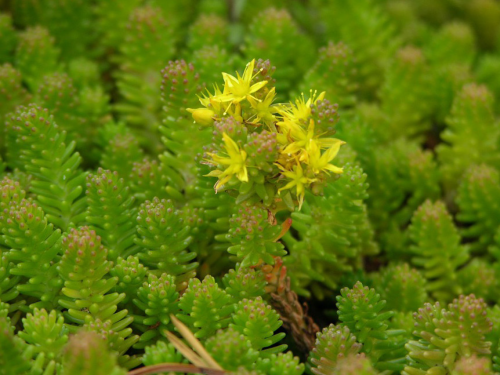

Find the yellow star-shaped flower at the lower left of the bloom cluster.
xmin=207 ymin=133 xmax=248 ymax=192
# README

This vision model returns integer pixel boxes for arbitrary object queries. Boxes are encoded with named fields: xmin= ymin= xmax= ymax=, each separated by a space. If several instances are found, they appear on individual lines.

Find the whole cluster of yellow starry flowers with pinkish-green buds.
xmin=188 ymin=60 xmax=344 ymax=210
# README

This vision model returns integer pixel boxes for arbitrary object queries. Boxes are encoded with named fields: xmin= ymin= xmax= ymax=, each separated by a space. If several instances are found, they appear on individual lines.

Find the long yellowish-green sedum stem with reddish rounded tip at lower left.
xmin=58 ymin=227 xmax=139 ymax=367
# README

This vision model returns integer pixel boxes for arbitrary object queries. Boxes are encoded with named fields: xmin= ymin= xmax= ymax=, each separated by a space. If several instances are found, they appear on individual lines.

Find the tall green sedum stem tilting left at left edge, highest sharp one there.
xmin=7 ymin=105 xmax=86 ymax=230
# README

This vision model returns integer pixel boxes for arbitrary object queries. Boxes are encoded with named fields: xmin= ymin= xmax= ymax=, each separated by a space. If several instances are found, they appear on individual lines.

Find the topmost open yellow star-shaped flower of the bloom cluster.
xmin=216 ymin=60 xmax=267 ymax=104
